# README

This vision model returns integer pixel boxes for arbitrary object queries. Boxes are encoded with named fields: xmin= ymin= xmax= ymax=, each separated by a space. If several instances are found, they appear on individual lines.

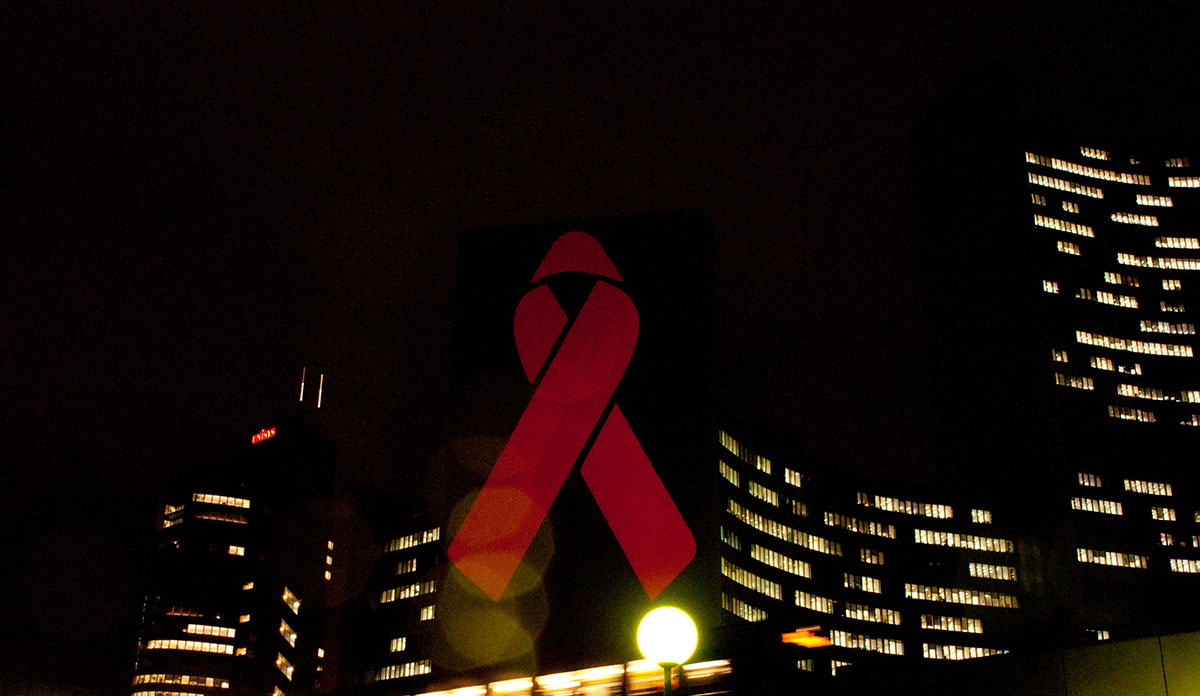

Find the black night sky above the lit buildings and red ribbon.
xmin=0 ymin=1 xmax=1200 ymax=690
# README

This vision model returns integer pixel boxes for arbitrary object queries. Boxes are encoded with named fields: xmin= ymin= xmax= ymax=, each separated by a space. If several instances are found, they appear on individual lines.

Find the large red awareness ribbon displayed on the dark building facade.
xmin=449 ymin=232 xmax=696 ymax=601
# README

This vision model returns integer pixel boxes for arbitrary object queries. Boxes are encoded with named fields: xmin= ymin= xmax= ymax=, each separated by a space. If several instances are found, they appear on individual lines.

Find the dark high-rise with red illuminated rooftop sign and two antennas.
xmin=131 ymin=419 xmax=340 ymax=696
